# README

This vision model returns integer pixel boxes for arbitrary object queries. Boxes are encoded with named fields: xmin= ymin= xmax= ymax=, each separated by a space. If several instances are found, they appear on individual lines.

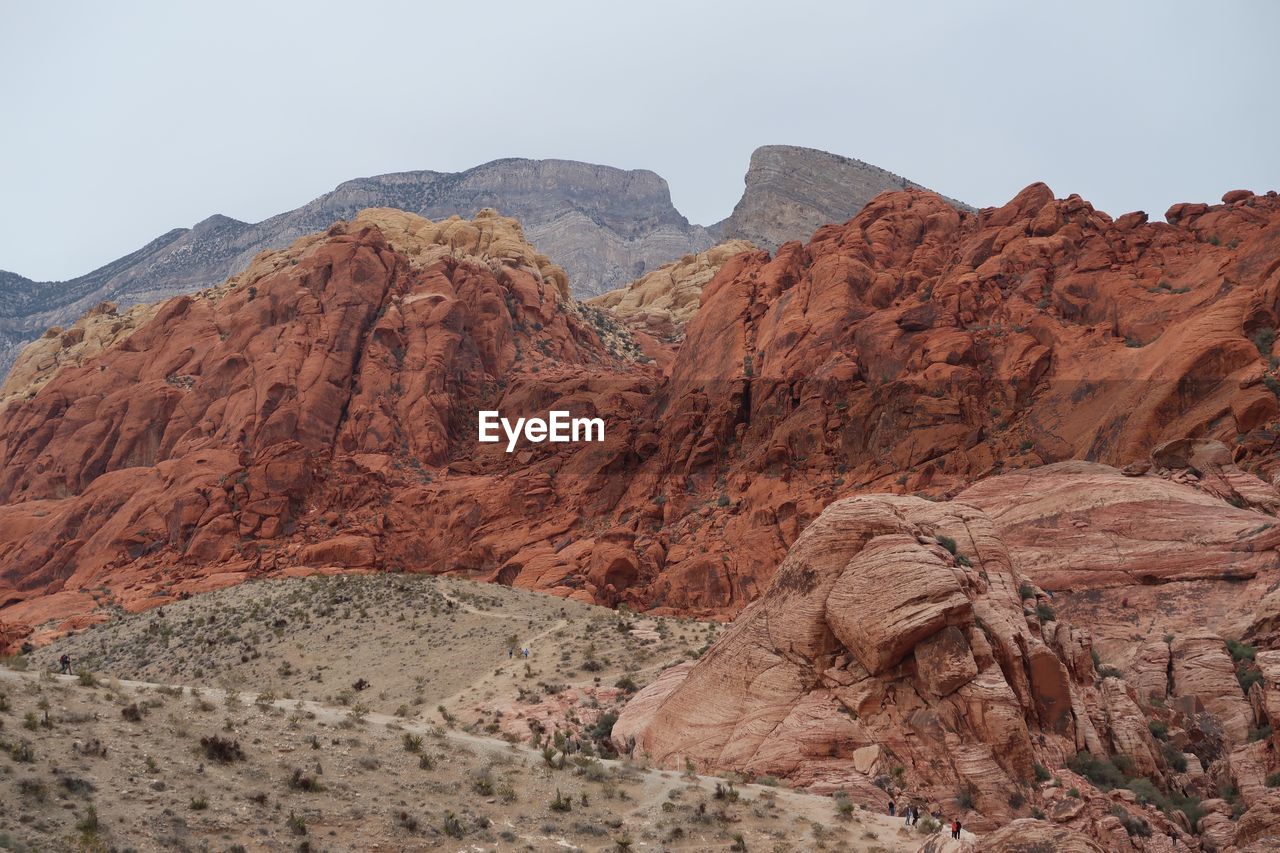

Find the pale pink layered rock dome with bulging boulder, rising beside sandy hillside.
xmin=613 ymin=496 xmax=1089 ymax=815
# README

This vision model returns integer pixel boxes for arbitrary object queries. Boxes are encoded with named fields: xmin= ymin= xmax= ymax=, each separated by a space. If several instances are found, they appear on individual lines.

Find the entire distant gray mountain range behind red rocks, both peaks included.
xmin=0 ymin=146 xmax=962 ymax=377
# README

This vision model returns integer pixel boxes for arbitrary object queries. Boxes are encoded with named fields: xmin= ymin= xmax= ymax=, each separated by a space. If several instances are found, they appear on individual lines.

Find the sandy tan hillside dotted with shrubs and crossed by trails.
xmin=0 ymin=575 xmax=934 ymax=852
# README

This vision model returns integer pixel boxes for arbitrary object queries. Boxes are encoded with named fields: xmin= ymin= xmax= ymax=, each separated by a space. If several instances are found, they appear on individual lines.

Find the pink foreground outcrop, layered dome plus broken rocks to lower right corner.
xmin=612 ymin=496 xmax=1280 ymax=850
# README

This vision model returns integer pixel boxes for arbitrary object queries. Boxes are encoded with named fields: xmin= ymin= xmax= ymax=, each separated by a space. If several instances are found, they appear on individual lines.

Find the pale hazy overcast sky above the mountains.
xmin=0 ymin=0 xmax=1280 ymax=279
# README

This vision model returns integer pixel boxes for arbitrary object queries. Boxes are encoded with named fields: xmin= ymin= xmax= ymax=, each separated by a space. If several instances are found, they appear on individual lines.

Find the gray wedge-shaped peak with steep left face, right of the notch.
xmin=714 ymin=145 xmax=972 ymax=251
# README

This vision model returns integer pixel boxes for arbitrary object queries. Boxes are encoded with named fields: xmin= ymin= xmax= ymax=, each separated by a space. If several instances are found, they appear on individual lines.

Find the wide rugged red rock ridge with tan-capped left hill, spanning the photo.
xmin=0 ymin=184 xmax=1280 ymax=650
